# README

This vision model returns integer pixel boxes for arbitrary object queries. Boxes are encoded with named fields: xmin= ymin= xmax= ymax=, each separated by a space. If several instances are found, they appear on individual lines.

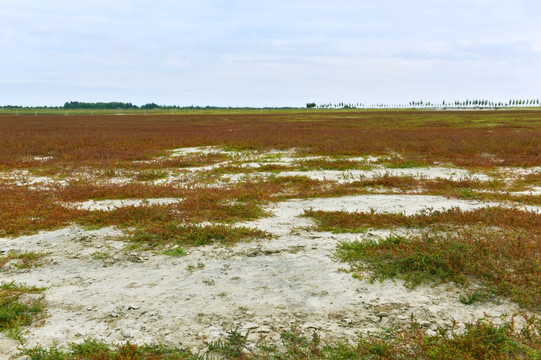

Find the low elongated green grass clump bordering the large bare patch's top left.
xmin=127 ymin=223 xmax=270 ymax=248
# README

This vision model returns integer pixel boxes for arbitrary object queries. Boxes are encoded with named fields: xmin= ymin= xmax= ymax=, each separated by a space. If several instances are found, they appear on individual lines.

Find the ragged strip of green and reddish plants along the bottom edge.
xmin=22 ymin=318 xmax=541 ymax=360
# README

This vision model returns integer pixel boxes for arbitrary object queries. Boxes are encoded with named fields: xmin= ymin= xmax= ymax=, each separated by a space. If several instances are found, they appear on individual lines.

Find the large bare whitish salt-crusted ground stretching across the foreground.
xmin=0 ymin=195 xmax=539 ymax=358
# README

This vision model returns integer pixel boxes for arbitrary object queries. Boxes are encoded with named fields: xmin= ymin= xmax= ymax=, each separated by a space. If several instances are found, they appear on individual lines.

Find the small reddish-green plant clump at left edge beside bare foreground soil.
xmin=0 ymin=282 xmax=44 ymax=331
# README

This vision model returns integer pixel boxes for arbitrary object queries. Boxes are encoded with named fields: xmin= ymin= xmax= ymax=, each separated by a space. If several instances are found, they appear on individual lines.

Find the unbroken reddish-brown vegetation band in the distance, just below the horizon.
xmin=0 ymin=110 xmax=541 ymax=169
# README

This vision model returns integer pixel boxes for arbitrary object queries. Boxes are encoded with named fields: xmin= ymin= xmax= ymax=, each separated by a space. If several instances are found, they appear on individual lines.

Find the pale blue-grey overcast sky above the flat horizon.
xmin=0 ymin=0 xmax=541 ymax=106
